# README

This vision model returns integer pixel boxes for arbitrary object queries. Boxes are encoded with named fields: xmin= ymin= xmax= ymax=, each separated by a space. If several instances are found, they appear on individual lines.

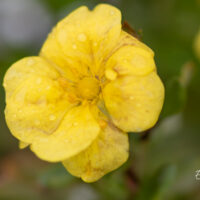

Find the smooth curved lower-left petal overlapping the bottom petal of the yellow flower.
xmin=31 ymin=106 xmax=100 ymax=162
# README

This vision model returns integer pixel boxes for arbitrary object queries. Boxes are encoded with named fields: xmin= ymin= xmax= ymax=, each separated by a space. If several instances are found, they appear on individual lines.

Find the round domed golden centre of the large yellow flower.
xmin=77 ymin=77 xmax=100 ymax=100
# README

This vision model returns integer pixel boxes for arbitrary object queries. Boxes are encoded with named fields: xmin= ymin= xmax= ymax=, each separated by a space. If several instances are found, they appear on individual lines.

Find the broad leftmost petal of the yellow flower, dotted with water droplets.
xmin=4 ymin=57 xmax=73 ymax=143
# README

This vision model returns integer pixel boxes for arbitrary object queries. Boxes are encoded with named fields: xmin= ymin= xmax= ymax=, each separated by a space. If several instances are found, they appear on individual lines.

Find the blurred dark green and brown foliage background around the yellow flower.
xmin=0 ymin=0 xmax=200 ymax=200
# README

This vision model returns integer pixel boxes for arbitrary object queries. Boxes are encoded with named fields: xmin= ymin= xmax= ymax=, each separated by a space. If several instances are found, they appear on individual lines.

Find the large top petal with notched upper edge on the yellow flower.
xmin=41 ymin=4 xmax=121 ymax=79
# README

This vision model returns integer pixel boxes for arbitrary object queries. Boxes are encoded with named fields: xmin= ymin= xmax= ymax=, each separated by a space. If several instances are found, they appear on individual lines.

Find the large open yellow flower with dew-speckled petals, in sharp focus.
xmin=4 ymin=4 xmax=164 ymax=182
